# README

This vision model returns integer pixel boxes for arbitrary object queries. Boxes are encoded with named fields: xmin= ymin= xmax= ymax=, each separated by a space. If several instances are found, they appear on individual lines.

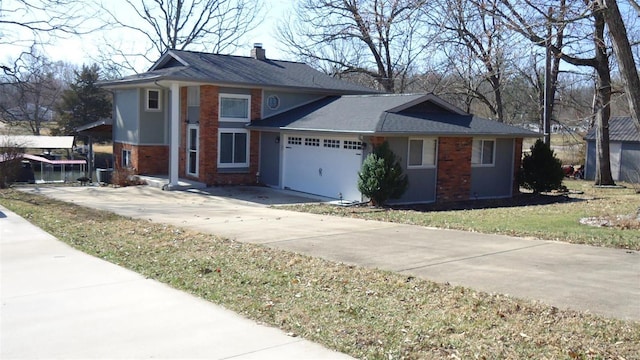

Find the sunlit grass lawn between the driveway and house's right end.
xmin=284 ymin=180 xmax=640 ymax=250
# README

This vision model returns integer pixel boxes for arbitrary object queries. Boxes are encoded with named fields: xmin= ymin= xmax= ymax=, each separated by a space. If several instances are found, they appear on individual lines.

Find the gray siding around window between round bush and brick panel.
xmin=384 ymin=137 xmax=436 ymax=204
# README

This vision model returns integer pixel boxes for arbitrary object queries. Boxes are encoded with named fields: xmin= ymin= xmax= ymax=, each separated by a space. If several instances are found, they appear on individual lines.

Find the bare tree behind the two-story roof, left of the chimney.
xmin=94 ymin=0 xmax=262 ymax=71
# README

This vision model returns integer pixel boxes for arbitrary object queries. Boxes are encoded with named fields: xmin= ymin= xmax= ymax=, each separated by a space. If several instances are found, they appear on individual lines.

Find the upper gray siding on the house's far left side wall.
xmin=113 ymin=89 xmax=140 ymax=144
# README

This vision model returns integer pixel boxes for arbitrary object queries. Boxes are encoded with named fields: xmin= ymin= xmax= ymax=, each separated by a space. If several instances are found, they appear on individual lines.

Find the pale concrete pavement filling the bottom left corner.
xmin=0 ymin=206 xmax=349 ymax=359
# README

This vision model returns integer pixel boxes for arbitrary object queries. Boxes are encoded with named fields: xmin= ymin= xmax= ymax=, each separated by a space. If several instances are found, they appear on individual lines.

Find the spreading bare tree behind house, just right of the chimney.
xmin=279 ymin=0 xmax=429 ymax=92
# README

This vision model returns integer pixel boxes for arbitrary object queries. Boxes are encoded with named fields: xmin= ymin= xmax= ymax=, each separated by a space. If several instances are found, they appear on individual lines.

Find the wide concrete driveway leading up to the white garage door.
xmin=15 ymin=186 xmax=640 ymax=321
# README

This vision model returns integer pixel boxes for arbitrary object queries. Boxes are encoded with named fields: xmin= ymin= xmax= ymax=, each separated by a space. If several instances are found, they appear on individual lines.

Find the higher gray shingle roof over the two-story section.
xmin=103 ymin=50 xmax=378 ymax=94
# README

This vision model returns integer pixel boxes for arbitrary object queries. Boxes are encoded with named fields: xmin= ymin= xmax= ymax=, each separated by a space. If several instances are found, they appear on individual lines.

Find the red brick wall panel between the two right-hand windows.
xmin=436 ymin=137 xmax=473 ymax=202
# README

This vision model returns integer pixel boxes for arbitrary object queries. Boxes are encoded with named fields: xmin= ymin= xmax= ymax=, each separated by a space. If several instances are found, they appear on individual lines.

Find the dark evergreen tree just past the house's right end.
xmin=520 ymin=139 xmax=564 ymax=194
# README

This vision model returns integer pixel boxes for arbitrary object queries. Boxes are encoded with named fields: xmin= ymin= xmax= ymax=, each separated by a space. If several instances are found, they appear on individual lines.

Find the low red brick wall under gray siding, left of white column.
xmin=113 ymin=142 xmax=169 ymax=175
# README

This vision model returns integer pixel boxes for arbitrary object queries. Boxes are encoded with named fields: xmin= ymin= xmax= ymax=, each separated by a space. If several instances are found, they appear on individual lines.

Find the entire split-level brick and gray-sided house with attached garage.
xmin=103 ymin=47 xmax=539 ymax=203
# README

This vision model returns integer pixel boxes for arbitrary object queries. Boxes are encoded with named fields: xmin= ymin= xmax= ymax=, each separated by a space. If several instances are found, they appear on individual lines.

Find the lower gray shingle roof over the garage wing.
xmin=250 ymin=95 xmax=539 ymax=137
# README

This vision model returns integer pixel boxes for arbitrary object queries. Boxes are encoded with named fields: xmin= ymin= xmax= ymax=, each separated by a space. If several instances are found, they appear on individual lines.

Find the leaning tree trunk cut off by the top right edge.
xmin=598 ymin=0 xmax=640 ymax=132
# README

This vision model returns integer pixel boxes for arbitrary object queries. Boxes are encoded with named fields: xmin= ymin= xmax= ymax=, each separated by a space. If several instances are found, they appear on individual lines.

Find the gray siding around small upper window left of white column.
xmin=139 ymin=89 xmax=169 ymax=145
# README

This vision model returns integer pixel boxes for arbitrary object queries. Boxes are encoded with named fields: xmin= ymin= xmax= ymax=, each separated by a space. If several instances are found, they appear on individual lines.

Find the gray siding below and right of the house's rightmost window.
xmin=469 ymin=139 xmax=513 ymax=200
